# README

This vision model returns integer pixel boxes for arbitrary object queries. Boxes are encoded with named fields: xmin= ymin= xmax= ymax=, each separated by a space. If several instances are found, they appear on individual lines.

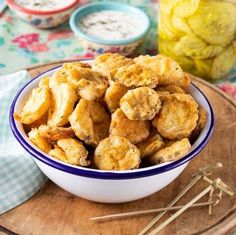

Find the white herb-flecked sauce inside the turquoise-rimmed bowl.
xmin=78 ymin=10 xmax=142 ymax=40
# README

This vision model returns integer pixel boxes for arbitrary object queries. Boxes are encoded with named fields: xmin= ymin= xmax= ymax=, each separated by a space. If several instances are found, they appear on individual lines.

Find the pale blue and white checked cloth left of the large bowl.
xmin=0 ymin=70 xmax=47 ymax=214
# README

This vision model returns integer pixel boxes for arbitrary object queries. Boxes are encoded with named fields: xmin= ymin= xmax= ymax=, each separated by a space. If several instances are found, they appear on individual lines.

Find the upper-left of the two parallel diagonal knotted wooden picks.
xmin=138 ymin=162 xmax=223 ymax=235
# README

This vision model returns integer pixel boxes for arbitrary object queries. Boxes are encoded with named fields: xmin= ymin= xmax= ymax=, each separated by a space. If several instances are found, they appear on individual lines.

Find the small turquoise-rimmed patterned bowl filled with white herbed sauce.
xmin=70 ymin=2 xmax=150 ymax=55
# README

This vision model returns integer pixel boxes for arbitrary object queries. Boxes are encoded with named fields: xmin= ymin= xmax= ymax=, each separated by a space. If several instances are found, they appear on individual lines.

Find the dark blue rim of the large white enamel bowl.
xmin=9 ymin=60 xmax=214 ymax=180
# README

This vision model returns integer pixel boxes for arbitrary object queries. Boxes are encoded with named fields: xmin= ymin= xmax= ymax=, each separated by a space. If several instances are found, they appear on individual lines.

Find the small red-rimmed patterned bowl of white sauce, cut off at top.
xmin=7 ymin=0 xmax=78 ymax=28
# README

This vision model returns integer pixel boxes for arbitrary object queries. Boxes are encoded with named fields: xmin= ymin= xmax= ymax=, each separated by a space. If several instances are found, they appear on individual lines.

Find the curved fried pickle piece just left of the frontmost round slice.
xmin=57 ymin=138 xmax=90 ymax=166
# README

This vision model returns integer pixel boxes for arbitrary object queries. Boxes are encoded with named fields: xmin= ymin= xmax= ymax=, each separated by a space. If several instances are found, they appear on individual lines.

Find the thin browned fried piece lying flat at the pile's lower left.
xmin=38 ymin=125 xmax=75 ymax=140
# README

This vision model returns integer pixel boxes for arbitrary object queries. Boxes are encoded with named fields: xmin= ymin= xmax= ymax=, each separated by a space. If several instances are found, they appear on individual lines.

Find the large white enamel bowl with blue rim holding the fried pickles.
xmin=10 ymin=61 xmax=214 ymax=203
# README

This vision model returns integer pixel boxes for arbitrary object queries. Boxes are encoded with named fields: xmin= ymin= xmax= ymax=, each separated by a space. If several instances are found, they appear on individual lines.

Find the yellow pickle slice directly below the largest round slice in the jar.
xmin=174 ymin=35 xmax=224 ymax=59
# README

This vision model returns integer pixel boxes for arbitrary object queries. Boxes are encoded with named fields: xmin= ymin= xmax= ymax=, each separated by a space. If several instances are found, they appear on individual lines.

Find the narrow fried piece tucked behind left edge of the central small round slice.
xmin=105 ymin=82 xmax=128 ymax=113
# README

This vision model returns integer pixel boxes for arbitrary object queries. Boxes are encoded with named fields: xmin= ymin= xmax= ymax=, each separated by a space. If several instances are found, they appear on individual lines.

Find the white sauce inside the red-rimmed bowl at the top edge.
xmin=15 ymin=0 xmax=74 ymax=11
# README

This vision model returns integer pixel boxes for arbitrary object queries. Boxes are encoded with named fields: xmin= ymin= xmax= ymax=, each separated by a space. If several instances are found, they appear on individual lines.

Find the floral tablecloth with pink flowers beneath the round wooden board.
xmin=0 ymin=0 xmax=236 ymax=99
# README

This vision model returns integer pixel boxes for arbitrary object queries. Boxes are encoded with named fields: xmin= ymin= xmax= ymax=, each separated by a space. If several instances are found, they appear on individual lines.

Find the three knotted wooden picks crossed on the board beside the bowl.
xmin=90 ymin=162 xmax=234 ymax=235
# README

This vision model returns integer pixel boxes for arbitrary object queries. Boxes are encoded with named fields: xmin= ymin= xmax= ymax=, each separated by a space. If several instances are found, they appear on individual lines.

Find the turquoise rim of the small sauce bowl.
xmin=70 ymin=2 xmax=151 ymax=45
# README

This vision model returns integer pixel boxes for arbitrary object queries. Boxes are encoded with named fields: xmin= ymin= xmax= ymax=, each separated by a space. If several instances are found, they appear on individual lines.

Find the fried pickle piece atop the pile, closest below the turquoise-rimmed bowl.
xmin=92 ymin=53 xmax=134 ymax=80
